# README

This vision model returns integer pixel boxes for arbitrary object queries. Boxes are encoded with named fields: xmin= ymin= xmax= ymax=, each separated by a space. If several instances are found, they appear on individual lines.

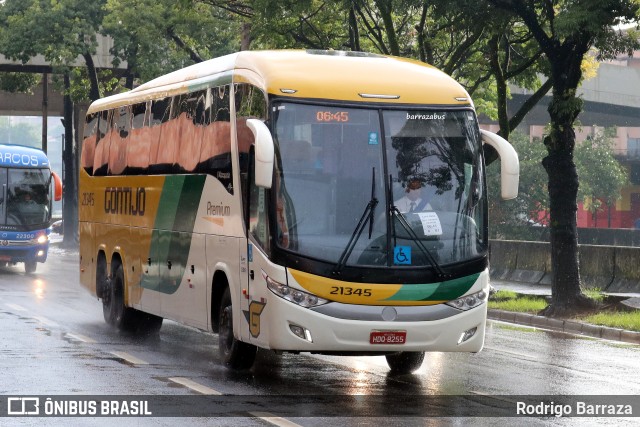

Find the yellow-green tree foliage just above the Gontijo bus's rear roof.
xmin=102 ymin=0 xmax=239 ymax=83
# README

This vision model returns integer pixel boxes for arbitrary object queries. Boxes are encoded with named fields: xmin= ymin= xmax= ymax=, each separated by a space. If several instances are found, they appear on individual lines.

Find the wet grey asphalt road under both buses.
xmin=0 ymin=242 xmax=640 ymax=426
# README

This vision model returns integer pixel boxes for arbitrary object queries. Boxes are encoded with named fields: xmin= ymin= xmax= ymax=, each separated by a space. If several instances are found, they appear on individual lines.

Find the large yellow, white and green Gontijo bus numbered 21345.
xmin=79 ymin=50 xmax=519 ymax=372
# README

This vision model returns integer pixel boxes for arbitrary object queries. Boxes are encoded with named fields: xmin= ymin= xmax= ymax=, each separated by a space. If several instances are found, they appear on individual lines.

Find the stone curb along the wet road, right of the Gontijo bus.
xmin=487 ymin=309 xmax=640 ymax=344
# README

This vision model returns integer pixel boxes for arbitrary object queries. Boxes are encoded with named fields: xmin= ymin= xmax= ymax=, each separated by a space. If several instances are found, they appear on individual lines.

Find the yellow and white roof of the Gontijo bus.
xmin=89 ymin=50 xmax=472 ymax=113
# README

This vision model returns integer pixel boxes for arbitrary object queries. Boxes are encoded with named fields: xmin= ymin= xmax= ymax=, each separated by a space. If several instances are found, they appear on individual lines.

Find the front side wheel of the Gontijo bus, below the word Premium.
xmin=218 ymin=288 xmax=258 ymax=369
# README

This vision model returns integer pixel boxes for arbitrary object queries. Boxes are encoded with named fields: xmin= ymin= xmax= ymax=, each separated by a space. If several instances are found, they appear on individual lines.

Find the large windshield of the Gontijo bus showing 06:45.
xmin=274 ymin=102 xmax=487 ymax=268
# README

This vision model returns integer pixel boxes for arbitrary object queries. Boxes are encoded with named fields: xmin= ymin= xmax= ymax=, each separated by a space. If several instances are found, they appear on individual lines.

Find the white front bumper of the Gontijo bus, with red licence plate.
xmin=252 ymin=297 xmax=487 ymax=353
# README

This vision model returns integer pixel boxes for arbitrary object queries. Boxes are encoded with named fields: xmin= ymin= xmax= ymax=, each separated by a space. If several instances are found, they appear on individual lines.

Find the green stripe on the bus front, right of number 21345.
xmin=386 ymin=273 xmax=480 ymax=301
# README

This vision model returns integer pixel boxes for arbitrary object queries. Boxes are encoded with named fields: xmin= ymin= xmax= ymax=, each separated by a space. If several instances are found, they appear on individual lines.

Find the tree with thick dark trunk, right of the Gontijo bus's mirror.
xmin=488 ymin=0 xmax=640 ymax=316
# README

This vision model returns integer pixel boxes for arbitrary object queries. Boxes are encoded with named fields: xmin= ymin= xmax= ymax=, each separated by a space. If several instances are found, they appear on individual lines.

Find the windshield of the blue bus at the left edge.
xmin=0 ymin=168 xmax=51 ymax=230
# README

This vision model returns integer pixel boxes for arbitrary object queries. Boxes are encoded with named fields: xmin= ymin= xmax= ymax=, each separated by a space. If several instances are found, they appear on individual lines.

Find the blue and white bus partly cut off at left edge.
xmin=0 ymin=144 xmax=62 ymax=273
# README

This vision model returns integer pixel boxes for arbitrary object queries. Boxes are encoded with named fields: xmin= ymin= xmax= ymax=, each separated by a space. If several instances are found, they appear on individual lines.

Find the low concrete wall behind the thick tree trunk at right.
xmin=489 ymin=240 xmax=640 ymax=293
